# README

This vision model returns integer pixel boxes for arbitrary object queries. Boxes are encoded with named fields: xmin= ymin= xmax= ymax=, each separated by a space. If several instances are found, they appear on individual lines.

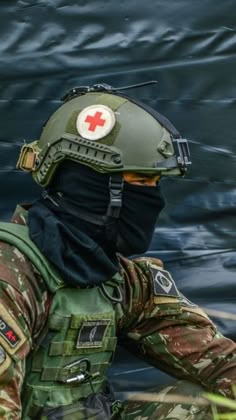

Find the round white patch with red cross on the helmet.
xmin=76 ymin=104 xmax=116 ymax=140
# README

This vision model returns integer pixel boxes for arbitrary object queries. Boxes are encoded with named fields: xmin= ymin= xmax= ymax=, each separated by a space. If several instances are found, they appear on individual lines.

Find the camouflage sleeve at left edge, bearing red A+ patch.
xmin=0 ymin=243 xmax=48 ymax=420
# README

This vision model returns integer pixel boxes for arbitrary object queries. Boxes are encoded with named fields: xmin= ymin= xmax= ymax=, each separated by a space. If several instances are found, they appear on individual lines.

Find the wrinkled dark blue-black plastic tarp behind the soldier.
xmin=0 ymin=0 xmax=236 ymax=390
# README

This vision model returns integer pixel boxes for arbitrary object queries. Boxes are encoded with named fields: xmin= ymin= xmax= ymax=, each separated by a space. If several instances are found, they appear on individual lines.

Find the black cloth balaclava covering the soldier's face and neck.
xmin=28 ymin=161 xmax=164 ymax=287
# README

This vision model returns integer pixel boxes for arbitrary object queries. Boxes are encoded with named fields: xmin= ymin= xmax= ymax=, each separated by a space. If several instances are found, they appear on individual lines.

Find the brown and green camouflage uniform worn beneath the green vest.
xmin=0 ymin=207 xmax=236 ymax=420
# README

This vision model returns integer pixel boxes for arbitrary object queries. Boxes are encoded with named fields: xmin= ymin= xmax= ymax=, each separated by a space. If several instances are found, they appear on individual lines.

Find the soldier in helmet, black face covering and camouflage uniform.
xmin=0 ymin=85 xmax=236 ymax=420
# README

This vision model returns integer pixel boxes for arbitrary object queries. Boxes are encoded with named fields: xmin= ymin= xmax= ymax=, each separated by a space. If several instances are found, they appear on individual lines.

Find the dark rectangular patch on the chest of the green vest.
xmin=76 ymin=319 xmax=110 ymax=349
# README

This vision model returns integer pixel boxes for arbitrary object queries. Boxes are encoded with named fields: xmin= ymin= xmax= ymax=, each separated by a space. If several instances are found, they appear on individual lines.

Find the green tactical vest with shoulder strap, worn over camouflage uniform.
xmin=0 ymin=223 xmax=122 ymax=419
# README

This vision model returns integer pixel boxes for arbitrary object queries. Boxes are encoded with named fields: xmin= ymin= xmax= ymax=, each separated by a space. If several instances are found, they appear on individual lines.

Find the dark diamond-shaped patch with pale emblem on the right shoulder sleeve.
xmin=150 ymin=265 xmax=179 ymax=297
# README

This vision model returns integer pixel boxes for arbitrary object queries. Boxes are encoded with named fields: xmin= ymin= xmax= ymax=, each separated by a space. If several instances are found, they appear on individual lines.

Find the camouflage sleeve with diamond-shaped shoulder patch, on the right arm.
xmin=119 ymin=258 xmax=236 ymax=396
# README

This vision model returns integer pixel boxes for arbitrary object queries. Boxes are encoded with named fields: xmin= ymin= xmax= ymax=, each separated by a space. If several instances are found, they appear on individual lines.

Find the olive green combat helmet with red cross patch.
xmin=17 ymin=85 xmax=191 ymax=187
